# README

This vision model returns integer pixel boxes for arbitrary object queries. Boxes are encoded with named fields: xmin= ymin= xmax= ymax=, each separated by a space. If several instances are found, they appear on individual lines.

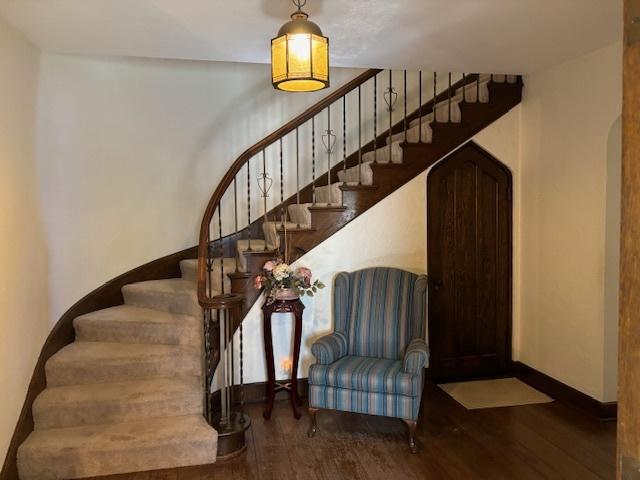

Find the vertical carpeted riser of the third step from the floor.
xmin=45 ymin=351 xmax=201 ymax=387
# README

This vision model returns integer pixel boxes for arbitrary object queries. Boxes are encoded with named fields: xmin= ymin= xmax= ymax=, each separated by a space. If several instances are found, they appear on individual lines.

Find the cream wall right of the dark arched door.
xmin=520 ymin=43 xmax=622 ymax=401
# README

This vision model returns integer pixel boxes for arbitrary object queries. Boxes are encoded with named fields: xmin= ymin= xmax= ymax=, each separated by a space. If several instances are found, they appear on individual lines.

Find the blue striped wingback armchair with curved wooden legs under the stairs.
xmin=309 ymin=267 xmax=429 ymax=453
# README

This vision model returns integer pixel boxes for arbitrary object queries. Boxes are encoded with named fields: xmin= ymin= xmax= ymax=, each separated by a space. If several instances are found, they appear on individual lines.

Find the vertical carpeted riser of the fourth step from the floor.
xmin=74 ymin=317 xmax=202 ymax=347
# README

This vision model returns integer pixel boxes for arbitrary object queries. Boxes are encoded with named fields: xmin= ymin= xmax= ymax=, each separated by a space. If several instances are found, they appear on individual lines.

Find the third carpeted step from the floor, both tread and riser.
xmin=45 ymin=342 xmax=201 ymax=387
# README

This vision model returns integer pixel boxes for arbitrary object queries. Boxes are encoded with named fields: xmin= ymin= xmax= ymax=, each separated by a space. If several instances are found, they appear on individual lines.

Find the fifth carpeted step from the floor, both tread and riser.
xmin=122 ymin=278 xmax=202 ymax=316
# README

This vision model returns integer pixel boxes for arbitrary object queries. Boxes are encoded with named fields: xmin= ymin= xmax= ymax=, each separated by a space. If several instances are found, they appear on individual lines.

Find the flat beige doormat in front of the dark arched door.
xmin=438 ymin=378 xmax=553 ymax=410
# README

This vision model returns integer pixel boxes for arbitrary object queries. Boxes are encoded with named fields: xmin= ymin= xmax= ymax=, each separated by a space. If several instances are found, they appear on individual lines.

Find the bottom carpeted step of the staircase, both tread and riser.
xmin=18 ymin=414 xmax=218 ymax=480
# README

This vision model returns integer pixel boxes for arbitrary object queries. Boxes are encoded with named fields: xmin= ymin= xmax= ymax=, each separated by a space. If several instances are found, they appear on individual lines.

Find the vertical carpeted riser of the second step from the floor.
xmin=33 ymin=387 xmax=202 ymax=430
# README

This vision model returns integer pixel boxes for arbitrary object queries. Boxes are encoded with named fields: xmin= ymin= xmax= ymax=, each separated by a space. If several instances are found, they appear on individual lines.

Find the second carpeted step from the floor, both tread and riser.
xmin=33 ymin=376 xmax=202 ymax=430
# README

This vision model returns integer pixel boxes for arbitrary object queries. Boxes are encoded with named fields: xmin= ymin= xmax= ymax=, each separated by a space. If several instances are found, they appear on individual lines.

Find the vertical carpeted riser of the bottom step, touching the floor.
xmin=18 ymin=431 xmax=218 ymax=480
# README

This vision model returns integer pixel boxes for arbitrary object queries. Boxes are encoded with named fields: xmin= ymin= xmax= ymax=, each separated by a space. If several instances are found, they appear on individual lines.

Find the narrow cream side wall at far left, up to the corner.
xmin=0 ymin=19 xmax=50 ymax=458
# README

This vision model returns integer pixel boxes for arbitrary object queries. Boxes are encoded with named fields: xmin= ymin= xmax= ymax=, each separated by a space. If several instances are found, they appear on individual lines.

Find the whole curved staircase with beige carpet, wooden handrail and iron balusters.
xmin=10 ymin=70 xmax=522 ymax=480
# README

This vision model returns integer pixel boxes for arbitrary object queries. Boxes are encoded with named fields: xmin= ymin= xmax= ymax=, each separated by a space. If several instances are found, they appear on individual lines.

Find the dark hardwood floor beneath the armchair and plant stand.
xmin=84 ymin=384 xmax=616 ymax=480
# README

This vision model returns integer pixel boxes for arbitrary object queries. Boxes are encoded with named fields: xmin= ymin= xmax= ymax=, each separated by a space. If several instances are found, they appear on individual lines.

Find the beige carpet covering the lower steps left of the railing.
xmin=17 ymin=259 xmax=218 ymax=480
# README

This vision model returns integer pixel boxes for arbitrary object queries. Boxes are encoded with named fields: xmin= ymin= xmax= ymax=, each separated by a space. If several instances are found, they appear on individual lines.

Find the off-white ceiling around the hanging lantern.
xmin=0 ymin=0 xmax=622 ymax=73
